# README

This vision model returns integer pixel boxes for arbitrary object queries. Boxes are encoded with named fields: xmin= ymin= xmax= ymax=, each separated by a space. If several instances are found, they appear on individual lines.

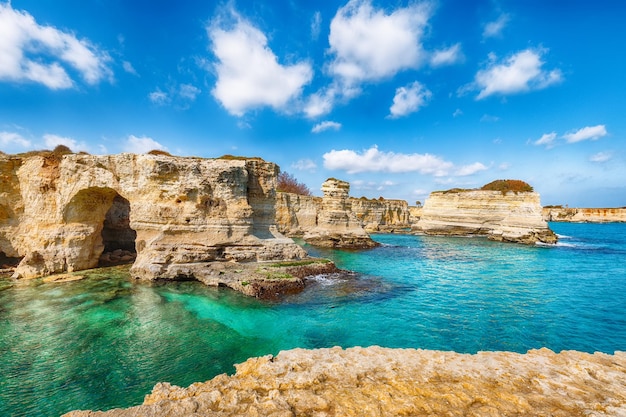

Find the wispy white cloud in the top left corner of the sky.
xmin=0 ymin=2 xmax=113 ymax=90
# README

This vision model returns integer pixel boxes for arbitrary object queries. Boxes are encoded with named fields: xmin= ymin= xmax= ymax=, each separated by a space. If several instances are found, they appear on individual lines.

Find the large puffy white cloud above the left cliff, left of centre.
xmin=207 ymin=10 xmax=313 ymax=116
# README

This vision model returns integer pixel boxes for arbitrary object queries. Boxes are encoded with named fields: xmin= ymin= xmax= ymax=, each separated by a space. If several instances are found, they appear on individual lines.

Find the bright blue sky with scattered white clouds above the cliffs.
xmin=0 ymin=0 xmax=626 ymax=207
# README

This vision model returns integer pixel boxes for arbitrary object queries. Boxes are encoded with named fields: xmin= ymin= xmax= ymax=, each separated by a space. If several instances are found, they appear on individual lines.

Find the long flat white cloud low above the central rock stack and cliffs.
xmin=323 ymin=146 xmax=454 ymax=176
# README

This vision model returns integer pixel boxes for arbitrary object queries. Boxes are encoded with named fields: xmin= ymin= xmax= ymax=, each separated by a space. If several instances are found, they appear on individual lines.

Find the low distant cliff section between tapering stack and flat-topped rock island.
xmin=350 ymin=198 xmax=411 ymax=233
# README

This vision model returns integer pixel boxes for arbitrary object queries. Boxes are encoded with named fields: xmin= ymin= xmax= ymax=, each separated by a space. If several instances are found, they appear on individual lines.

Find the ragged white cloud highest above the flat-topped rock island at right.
xmin=469 ymin=49 xmax=563 ymax=100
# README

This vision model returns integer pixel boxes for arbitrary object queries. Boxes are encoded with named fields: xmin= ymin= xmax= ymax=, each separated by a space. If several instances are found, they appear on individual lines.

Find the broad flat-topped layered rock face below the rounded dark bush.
xmin=417 ymin=190 xmax=557 ymax=244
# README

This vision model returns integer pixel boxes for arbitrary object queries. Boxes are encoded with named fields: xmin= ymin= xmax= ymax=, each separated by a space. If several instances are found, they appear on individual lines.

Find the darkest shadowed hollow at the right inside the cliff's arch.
xmin=98 ymin=194 xmax=137 ymax=267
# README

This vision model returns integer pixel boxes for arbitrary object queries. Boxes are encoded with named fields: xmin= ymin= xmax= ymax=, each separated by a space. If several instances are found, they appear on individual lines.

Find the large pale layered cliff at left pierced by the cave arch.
xmin=0 ymin=153 xmax=307 ymax=279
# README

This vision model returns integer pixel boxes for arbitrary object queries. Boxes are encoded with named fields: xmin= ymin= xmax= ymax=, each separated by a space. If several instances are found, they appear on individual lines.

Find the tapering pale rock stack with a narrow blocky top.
xmin=303 ymin=178 xmax=378 ymax=248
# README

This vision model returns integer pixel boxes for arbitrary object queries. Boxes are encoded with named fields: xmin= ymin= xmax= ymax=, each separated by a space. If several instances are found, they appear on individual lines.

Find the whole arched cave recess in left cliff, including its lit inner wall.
xmin=63 ymin=187 xmax=136 ymax=269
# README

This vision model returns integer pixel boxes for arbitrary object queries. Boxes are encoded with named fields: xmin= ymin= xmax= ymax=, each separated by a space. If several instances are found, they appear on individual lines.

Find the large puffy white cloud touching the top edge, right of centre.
xmin=328 ymin=0 xmax=431 ymax=87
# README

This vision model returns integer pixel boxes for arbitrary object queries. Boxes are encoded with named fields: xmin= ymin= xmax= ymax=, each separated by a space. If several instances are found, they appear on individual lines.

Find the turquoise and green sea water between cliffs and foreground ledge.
xmin=0 ymin=223 xmax=626 ymax=416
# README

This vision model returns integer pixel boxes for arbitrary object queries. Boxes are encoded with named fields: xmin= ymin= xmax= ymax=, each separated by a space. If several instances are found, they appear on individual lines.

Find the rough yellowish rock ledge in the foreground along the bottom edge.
xmin=65 ymin=347 xmax=626 ymax=417
